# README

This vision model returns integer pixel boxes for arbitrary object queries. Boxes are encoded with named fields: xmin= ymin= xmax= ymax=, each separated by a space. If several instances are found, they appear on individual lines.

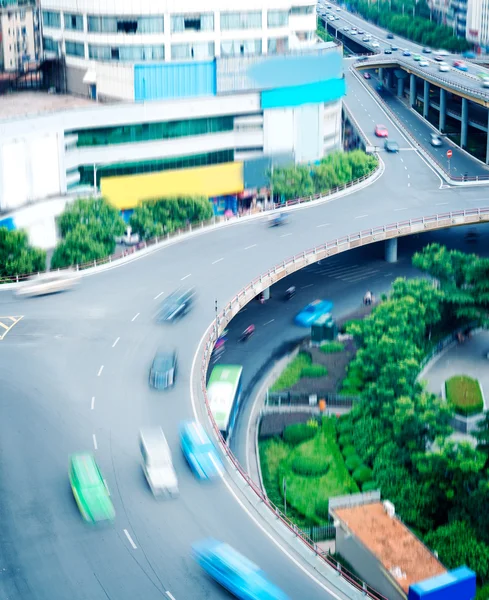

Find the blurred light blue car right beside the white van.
xmin=180 ymin=421 xmax=223 ymax=479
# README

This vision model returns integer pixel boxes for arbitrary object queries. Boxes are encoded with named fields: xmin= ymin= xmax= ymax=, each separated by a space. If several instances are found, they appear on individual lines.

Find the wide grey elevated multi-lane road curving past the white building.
xmin=0 ymin=29 xmax=487 ymax=600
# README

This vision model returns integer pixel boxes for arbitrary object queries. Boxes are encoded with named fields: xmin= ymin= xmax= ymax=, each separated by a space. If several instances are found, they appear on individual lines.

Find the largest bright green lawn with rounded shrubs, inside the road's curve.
xmin=260 ymin=418 xmax=359 ymax=526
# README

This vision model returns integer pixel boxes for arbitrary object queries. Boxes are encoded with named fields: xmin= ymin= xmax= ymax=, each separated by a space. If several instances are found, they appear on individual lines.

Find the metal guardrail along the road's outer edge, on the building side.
xmin=0 ymin=164 xmax=380 ymax=285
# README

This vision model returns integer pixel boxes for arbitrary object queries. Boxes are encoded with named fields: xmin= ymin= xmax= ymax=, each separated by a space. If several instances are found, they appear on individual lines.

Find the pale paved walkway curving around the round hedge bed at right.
xmin=423 ymin=330 xmax=489 ymax=409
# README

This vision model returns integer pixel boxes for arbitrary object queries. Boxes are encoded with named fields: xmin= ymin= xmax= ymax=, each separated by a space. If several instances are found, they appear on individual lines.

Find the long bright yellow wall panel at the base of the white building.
xmin=100 ymin=162 xmax=243 ymax=210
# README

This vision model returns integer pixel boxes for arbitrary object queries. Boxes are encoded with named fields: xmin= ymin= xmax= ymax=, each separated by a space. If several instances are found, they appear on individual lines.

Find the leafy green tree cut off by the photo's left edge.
xmin=0 ymin=227 xmax=46 ymax=277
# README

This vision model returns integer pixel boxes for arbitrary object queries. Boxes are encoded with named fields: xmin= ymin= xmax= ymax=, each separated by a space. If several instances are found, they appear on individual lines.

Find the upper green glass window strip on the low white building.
xmin=67 ymin=116 xmax=234 ymax=147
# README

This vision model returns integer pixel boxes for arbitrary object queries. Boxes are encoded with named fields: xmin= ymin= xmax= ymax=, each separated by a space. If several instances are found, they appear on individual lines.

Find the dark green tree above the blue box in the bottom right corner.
xmin=425 ymin=521 xmax=489 ymax=581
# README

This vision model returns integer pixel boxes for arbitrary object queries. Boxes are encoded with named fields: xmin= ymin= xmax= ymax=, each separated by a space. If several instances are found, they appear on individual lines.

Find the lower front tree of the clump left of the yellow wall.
xmin=51 ymin=224 xmax=110 ymax=269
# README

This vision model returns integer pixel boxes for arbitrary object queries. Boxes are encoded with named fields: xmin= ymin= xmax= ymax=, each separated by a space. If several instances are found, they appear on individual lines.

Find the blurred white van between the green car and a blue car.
xmin=139 ymin=427 xmax=178 ymax=498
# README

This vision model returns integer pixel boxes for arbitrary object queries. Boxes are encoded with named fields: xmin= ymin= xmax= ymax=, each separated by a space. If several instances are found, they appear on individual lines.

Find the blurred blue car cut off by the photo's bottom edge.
xmin=192 ymin=539 xmax=288 ymax=600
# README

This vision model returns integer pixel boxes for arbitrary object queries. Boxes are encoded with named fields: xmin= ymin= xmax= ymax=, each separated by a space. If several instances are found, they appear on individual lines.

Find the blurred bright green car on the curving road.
xmin=70 ymin=452 xmax=115 ymax=523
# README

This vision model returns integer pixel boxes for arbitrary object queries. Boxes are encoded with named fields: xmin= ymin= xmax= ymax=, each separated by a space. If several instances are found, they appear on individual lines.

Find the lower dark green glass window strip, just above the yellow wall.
xmin=78 ymin=150 xmax=234 ymax=187
